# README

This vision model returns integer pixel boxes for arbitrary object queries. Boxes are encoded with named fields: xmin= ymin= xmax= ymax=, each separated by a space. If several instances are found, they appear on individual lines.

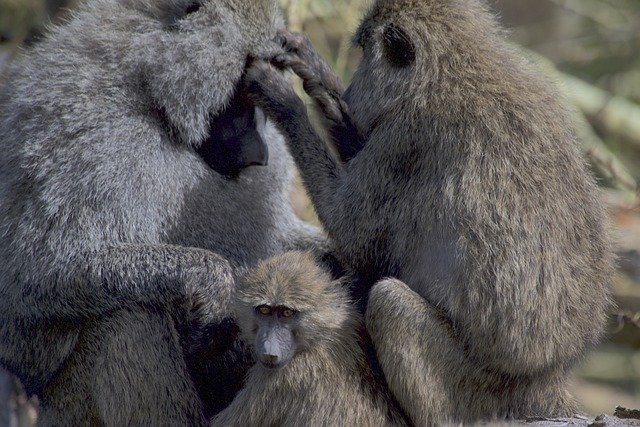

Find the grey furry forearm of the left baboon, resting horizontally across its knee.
xmin=20 ymin=244 xmax=233 ymax=322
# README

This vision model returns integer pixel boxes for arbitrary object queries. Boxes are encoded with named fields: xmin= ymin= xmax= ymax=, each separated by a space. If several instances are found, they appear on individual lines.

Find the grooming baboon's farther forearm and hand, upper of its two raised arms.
xmin=274 ymin=30 xmax=366 ymax=162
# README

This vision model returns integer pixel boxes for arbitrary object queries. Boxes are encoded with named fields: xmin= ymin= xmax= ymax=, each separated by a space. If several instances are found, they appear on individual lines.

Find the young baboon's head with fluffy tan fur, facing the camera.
xmin=235 ymin=252 xmax=349 ymax=368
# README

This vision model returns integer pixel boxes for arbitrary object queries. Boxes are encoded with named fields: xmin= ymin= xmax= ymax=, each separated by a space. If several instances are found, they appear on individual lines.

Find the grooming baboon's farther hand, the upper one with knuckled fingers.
xmin=272 ymin=30 xmax=344 ymax=121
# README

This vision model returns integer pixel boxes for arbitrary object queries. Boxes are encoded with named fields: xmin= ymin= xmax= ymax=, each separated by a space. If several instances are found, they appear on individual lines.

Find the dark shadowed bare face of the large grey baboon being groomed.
xmin=196 ymin=88 xmax=269 ymax=179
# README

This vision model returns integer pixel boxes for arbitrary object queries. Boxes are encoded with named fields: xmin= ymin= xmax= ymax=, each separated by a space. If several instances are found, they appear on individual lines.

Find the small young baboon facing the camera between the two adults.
xmin=212 ymin=252 xmax=403 ymax=426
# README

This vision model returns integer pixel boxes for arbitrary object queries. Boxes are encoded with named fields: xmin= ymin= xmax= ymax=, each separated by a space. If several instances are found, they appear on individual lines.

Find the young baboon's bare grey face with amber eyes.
xmin=254 ymin=305 xmax=299 ymax=369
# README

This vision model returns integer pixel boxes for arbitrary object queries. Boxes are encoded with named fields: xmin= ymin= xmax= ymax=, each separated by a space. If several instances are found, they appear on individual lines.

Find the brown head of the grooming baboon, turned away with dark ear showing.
xmin=344 ymin=0 xmax=496 ymax=136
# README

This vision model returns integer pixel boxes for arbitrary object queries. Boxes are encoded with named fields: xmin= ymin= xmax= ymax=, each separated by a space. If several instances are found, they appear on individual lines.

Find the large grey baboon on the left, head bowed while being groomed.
xmin=0 ymin=0 xmax=321 ymax=425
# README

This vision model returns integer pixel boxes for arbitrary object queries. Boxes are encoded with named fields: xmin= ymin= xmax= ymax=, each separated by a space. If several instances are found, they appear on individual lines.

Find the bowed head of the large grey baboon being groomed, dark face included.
xmin=105 ymin=0 xmax=284 ymax=177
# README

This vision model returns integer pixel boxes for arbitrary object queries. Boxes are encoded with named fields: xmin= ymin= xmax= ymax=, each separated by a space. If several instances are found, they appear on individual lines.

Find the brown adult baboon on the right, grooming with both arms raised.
xmin=246 ymin=0 xmax=613 ymax=425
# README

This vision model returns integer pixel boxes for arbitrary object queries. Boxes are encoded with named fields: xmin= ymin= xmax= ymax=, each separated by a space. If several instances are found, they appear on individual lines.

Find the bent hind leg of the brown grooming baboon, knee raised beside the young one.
xmin=366 ymin=279 xmax=576 ymax=425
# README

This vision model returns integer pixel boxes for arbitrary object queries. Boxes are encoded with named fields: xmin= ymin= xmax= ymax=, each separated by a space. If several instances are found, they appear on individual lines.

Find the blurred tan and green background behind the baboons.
xmin=0 ymin=0 xmax=640 ymax=418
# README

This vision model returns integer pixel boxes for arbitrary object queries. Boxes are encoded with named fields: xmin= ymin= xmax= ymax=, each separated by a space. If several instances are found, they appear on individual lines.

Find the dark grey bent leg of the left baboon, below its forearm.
xmin=41 ymin=308 xmax=204 ymax=426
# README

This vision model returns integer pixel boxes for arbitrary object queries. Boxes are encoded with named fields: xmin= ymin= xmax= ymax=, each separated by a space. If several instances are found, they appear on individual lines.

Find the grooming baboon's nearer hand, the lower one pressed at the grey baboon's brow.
xmin=245 ymin=60 xmax=306 ymax=124
